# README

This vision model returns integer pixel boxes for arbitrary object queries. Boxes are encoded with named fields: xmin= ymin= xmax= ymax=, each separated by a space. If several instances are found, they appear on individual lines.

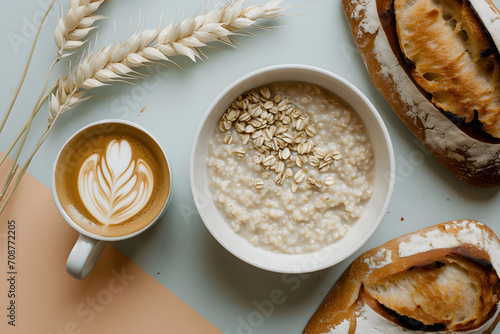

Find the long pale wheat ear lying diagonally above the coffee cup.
xmin=49 ymin=0 xmax=284 ymax=122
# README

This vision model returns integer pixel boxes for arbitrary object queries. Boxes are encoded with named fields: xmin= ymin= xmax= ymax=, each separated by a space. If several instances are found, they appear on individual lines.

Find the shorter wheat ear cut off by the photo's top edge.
xmin=54 ymin=0 xmax=105 ymax=58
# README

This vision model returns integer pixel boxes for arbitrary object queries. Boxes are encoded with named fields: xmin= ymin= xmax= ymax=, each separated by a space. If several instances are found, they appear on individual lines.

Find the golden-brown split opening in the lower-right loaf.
xmin=362 ymin=253 xmax=500 ymax=331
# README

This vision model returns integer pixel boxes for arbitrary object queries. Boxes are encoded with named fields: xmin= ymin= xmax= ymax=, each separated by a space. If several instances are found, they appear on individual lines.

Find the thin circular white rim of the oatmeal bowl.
xmin=189 ymin=64 xmax=395 ymax=274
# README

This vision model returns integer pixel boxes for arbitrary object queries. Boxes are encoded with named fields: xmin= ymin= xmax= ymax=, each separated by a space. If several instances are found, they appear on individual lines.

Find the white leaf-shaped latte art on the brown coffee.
xmin=78 ymin=139 xmax=154 ymax=226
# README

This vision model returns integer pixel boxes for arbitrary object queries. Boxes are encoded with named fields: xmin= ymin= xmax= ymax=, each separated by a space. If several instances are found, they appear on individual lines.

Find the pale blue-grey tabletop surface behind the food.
xmin=0 ymin=0 xmax=500 ymax=334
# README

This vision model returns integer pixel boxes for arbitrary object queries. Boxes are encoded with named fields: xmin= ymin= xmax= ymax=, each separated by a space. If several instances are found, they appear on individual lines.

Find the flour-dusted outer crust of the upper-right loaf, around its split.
xmin=342 ymin=0 xmax=500 ymax=187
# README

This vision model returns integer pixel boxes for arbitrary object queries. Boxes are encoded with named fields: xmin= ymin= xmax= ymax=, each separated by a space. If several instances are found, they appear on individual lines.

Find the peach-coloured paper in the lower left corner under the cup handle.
xmin=0 ymin=157 xmax=222 ymax=334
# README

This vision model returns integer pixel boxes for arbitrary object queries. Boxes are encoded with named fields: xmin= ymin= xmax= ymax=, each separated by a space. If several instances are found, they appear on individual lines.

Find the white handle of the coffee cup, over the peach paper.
xmin=66 ymin=234 xmax=107 ymax=279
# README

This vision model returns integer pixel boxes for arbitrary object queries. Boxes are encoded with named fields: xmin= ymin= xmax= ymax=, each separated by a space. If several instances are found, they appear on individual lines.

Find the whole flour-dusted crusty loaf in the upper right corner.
xmin=342 ymin=0 xmax=500 ymax=187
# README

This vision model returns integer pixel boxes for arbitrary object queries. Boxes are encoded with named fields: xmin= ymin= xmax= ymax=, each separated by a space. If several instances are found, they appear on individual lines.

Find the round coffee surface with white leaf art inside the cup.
xmin=54 ymin=123 xmax=170 ymax=237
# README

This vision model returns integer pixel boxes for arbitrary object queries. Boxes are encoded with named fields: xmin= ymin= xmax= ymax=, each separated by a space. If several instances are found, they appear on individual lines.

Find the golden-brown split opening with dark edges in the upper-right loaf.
xmin=388 ymin=0 xmax=500 ymax=143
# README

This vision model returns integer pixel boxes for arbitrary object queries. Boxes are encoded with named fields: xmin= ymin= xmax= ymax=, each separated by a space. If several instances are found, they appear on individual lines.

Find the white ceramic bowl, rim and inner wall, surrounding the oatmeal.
xmin=190 ymin=65 xmax=395 ymax=273
